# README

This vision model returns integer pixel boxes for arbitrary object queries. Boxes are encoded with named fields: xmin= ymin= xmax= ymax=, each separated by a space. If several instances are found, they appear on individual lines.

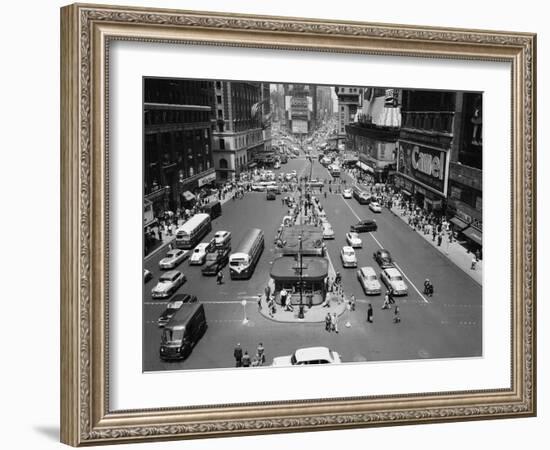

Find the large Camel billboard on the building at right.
xmin=397 ymin=141 xmax=449 ymax=197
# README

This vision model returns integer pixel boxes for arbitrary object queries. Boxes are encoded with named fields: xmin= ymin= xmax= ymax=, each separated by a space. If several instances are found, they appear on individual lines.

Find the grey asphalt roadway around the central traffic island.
xmin=143 ymin=156 xmax=483 ymax=371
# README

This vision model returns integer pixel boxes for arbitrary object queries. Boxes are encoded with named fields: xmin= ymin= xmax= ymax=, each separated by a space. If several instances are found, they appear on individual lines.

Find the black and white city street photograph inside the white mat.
xmin=143 ymin=77 xmax=483 ymax=372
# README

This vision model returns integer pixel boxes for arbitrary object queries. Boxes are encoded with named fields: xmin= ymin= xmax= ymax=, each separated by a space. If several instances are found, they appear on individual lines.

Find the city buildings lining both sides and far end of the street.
xmin=144 ymin=78 xmax=483 ymax=250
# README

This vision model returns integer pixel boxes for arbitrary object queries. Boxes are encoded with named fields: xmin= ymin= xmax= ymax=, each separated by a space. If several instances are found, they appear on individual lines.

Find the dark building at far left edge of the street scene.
xmin=143 ymin=78 xmax=215 ymax=216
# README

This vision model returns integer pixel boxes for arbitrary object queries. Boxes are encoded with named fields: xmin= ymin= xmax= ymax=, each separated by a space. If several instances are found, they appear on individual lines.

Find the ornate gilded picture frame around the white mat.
xmin=61 ymin=4 xmax=536 ymax=446
